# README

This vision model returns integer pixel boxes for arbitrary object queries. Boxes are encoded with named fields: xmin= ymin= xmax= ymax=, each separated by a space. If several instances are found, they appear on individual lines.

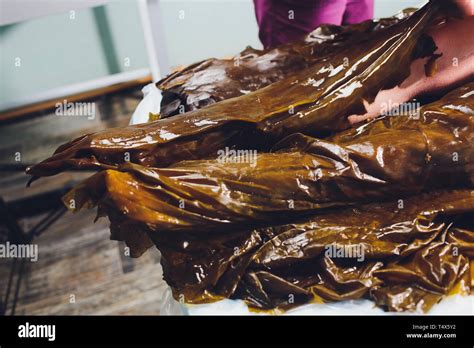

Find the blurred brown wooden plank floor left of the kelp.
xmin=0 ymin=89 xmax=167 ymax=315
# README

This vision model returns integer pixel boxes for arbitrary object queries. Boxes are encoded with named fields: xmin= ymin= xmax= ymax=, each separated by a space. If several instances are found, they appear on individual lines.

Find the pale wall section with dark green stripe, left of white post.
xmin=0 ymin=0 xmax=148 ymax=104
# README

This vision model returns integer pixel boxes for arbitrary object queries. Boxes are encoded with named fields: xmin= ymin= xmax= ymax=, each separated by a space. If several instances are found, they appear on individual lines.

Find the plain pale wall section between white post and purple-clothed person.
xmin=161 ymin=0 xmax=262 ymax=66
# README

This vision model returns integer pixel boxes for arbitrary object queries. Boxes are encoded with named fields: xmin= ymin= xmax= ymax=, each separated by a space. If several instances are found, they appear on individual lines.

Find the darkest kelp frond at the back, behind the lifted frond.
xmin=156 ymin=9 xmax=414 ymax=118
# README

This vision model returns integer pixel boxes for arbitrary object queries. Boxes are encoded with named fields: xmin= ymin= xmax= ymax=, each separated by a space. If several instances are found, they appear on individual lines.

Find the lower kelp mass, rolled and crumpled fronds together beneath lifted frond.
xmin=65 ymin=83 xmax=474 ymax=311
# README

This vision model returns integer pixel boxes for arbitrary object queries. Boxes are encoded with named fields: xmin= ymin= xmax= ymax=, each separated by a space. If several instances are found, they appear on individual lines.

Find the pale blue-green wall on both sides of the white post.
xmin=0 ymin=0 xmax=260 ymax=105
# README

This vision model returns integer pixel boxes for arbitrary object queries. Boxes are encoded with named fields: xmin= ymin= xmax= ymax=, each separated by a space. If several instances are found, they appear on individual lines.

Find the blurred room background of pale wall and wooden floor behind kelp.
xmin=0 ymin=0 xmax=426 ymax=314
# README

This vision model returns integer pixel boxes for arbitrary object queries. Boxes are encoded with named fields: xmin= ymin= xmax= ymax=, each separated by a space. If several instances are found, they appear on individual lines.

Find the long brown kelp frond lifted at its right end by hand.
xmin=27 ymin=2 xmax=438 ymax=181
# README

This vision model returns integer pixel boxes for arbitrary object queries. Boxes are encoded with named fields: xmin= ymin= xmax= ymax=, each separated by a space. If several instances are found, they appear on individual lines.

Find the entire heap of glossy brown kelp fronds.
xmin=28 ymin=2 xmax=474 ymax=312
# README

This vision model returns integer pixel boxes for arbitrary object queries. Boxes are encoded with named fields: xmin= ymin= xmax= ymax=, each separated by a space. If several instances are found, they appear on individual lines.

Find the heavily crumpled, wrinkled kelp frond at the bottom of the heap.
xmin=156 ymin=190 xmax=474 ymax=311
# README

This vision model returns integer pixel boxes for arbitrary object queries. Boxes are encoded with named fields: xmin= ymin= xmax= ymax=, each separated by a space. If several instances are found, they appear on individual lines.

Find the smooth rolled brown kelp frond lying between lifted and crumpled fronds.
xmin=61 ymin=84 xmax=474 ymax=231
